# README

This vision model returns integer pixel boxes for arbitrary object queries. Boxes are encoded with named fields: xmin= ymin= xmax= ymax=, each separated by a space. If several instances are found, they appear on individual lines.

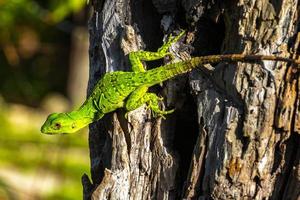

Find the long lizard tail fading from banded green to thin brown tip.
xmin=145 ymin=54 xmax=300 ymax=85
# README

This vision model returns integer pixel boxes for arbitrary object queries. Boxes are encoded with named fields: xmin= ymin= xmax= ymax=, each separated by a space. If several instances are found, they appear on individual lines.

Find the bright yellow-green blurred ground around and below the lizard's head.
xmin=0 ymin=98 xmax=89 ymax=200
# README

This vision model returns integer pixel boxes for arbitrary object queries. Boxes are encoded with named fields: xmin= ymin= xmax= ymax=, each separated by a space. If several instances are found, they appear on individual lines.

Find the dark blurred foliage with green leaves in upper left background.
xmin=0 ymin=0 xmax=86 ymax=106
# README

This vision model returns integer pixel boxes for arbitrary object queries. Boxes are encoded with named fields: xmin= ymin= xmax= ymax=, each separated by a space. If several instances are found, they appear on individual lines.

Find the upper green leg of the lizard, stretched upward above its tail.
xmin=129 ymin=31 xmax=184 ymax=72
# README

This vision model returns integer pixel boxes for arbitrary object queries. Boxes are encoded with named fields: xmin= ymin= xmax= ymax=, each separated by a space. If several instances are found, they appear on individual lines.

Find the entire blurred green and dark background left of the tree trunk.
xmin=0 ymin=0 xmax=89 ymax=200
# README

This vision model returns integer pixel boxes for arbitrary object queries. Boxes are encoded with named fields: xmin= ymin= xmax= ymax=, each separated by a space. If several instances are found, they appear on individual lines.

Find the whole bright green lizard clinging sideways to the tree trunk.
xmin=41 ymin=32 xmax=300 ymax=134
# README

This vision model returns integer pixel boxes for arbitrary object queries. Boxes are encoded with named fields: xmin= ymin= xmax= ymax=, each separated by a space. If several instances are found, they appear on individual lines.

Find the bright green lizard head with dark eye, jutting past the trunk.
xmin=41 ymin=113 xmax=87 ymax=135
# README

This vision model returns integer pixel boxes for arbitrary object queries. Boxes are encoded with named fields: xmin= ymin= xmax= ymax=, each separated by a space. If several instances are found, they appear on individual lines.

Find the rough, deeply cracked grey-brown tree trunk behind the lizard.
xmin=82 ymin=0 xmax=300 ymax=200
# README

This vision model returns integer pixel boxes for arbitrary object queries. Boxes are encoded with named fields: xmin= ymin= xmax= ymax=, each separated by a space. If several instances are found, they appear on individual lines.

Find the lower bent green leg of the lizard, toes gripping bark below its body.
xmin=125 ymin=86 xmax=174 ymax=117
